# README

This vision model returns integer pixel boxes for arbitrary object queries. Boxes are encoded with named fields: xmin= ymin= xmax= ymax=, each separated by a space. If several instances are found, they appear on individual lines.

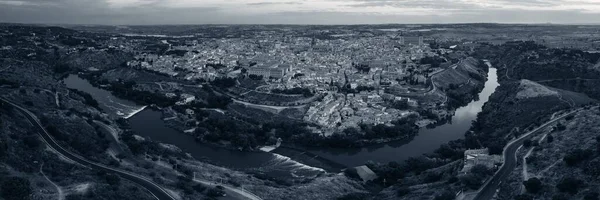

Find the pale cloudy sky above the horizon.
xmin=0 ymin=0 xmax=600 ymax=25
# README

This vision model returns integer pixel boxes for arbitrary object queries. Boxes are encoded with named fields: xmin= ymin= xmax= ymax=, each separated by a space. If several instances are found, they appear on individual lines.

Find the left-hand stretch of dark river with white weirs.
xmin=63 ymin=75 xmax=325 ymax=179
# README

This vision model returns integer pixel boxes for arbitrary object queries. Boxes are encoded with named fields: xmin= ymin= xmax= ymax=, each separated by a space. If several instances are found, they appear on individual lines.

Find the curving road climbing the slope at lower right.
xmin=474 ymin=109 xmax=579 ymax=200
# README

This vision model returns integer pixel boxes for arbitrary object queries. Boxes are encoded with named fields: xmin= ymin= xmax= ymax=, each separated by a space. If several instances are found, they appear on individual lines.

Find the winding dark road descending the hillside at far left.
xmin=0 ymin=97 xmax=175 ymax=200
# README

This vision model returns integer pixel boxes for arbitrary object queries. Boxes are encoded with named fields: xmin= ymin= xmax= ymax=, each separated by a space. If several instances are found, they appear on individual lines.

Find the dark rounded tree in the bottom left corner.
xmin=0 ymin=177 xmax=33 ymax=200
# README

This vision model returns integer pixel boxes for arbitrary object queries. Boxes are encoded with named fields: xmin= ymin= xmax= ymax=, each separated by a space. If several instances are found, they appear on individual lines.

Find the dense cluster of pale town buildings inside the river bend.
xmin=113 ymin=31 xmax=464 ymax=132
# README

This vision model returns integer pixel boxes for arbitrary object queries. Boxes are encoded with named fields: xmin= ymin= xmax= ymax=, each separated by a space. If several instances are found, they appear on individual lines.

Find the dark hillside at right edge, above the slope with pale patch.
xmin=474 ymin=42 xmax=600 ymax=99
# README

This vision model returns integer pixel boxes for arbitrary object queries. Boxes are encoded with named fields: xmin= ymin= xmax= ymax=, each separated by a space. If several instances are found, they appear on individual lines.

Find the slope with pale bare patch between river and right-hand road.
xmin=466 ymin=80 xmax=596 ymax=153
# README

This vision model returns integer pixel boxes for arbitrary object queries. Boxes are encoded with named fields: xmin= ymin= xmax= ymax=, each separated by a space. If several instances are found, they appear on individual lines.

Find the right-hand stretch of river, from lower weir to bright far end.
xmin=302 ymin=67 xmax=500 ymax=166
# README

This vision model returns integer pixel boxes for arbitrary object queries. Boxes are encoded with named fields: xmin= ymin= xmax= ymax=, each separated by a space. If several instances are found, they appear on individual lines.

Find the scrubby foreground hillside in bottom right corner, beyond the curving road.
xmin=500 ymin=107 xmax=600 ymax=199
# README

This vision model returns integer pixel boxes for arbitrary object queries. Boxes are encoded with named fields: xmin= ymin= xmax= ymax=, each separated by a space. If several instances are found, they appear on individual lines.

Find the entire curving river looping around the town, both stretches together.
xmin=63 ymin=65 xmax=499 ymax=178
